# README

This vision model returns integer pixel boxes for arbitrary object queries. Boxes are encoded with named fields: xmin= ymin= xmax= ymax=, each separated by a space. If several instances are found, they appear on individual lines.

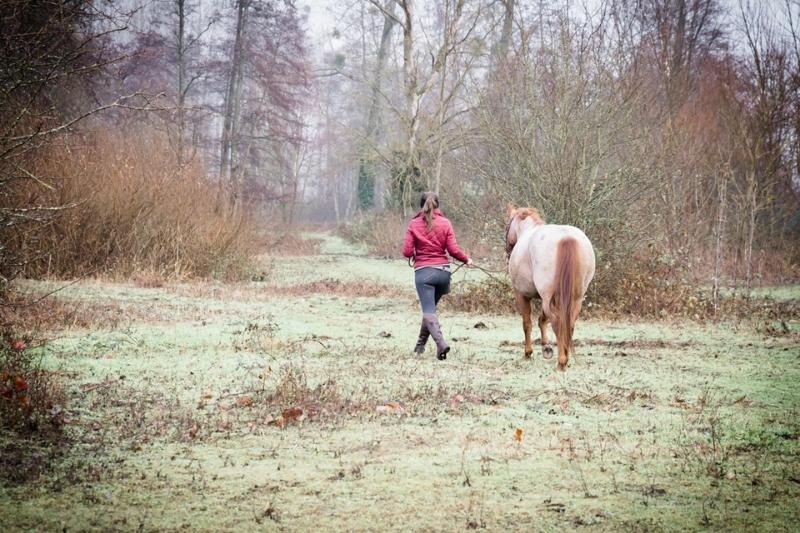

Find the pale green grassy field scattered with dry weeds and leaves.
xmin=0 ymin=237 xmax=800 ymax=531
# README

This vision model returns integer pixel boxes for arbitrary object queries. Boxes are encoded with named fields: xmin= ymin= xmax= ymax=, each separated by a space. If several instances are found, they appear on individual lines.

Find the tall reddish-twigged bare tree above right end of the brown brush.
xmin=220 ymin=0 xmax=309 ymax=205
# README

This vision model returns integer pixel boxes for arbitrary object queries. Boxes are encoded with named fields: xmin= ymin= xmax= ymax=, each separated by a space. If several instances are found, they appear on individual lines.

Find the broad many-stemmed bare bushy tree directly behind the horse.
xmin=462 ymin=5 xmax=657 ymax=274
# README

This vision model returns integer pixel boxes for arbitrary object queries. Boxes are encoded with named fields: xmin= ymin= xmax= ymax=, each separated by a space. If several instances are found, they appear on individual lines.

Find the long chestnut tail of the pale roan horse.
xmin=550 ymin=237 xmax=582 ymax=351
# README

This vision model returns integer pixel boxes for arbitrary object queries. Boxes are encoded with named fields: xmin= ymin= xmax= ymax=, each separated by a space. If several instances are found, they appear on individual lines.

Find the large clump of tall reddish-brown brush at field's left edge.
xmin=7 ymin=131 xmax=255 ymax=279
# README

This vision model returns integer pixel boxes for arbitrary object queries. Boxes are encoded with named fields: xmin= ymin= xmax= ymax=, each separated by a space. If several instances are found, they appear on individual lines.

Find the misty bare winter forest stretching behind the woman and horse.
xmin=0 ymin=0 xmax=800 ymax=290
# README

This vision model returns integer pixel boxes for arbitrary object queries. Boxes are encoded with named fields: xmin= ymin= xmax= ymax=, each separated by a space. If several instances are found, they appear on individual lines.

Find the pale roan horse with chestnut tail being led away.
xmin=506 ymin=204 xmax=595 ymax=372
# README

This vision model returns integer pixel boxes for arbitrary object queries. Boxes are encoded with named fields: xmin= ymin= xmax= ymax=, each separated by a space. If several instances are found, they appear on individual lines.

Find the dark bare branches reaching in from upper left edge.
xmin=0 ymin=0 xmax=150 ymax=293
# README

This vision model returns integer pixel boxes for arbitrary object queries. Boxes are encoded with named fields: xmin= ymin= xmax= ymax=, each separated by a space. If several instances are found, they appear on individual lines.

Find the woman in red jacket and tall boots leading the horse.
xmin=403 ymin=192 xmax=472 ymax=361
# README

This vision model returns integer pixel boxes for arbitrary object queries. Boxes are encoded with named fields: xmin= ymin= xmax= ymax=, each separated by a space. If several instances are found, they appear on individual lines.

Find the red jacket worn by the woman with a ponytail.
xmin=403 ymin=209 xmax=469 ymax=268
